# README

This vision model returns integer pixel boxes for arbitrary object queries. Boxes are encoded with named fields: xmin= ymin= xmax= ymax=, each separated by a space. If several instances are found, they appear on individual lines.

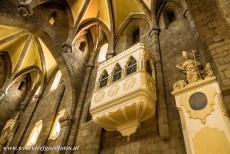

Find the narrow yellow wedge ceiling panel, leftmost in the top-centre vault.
xmin=67 ymin=0 xmax=85 ymax=23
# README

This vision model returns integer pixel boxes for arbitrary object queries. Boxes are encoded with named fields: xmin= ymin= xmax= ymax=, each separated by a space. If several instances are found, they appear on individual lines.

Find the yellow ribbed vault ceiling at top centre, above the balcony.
xmin=67 ymin=0 xmax=146 ymax=32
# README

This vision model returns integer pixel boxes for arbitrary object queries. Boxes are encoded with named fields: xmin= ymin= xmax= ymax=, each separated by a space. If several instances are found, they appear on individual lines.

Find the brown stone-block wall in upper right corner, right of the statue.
xmin=187 ymin=0 xmax=230 ymax=108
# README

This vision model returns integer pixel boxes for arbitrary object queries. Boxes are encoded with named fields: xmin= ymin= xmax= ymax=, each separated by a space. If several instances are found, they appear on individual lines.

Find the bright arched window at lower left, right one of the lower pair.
xmin=49 ymin=109 xmax=65 ymax=140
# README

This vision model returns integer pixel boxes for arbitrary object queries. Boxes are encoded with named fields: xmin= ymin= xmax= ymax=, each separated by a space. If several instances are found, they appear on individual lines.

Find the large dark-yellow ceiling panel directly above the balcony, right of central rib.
xmin=112 ymin=0 xmax=143 ymax=31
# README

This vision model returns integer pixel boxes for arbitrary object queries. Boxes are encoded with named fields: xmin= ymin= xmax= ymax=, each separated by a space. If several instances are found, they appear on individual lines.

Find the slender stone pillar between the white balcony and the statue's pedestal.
xmin=149 ymin=28 xmax=169 ymax=139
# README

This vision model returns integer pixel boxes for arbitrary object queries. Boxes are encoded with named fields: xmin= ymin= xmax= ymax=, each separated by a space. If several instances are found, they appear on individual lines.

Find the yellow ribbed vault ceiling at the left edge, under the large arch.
xmin=0 ymin=25 xmax=57 ymax=88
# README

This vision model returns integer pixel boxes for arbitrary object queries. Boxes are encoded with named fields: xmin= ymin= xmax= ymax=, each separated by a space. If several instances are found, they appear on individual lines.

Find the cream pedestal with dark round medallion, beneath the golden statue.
xmin=172 ymin=77 xmax=230 ymax=154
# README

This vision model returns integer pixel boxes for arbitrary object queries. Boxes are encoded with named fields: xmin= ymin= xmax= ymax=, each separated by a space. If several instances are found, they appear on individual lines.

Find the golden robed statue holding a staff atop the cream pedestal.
xmin=176 ymin=50 xmax=201 ymax=84
